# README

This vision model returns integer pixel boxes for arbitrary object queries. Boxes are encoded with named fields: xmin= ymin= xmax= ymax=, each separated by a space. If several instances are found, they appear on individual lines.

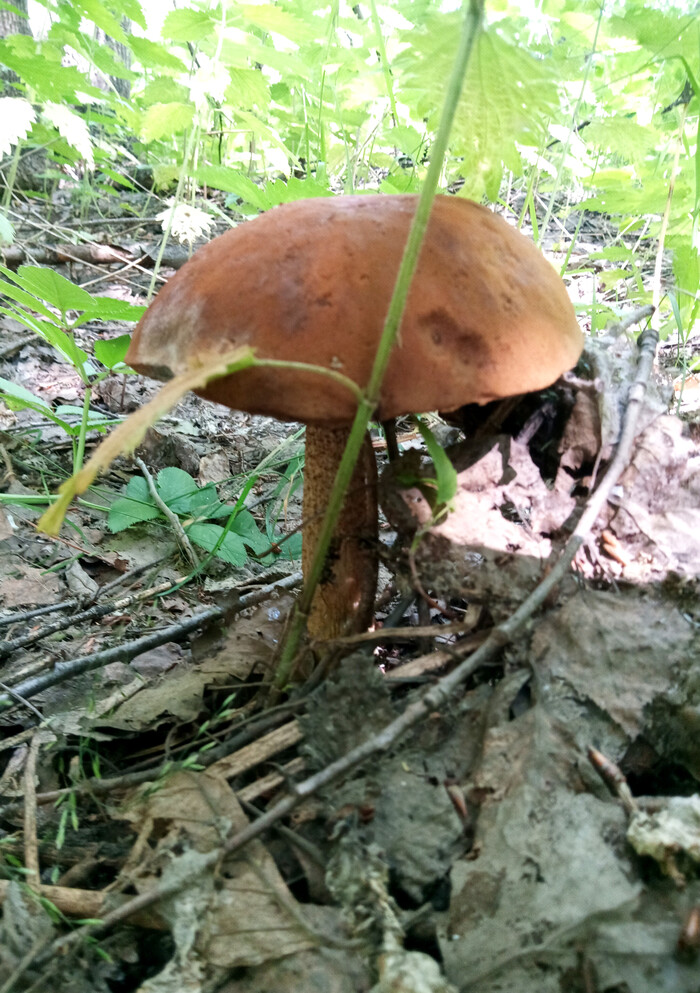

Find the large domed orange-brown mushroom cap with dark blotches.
xmin=126 ymin=195 xmax=583 ymax=425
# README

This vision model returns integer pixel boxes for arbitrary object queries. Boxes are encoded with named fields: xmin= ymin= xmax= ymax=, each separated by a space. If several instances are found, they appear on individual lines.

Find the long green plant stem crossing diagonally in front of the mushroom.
xmin=275 ymin=0 xmax=484 ymax=689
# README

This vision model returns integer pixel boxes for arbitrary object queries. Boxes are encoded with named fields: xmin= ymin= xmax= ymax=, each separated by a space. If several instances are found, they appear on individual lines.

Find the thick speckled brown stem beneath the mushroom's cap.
xmin=302 ymin=425 xmax=378 ymax=640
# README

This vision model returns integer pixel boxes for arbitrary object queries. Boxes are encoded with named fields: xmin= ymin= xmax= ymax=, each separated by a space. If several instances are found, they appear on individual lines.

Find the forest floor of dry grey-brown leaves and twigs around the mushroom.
xmin=0 ymin=188 xmax=700 ymax=993
